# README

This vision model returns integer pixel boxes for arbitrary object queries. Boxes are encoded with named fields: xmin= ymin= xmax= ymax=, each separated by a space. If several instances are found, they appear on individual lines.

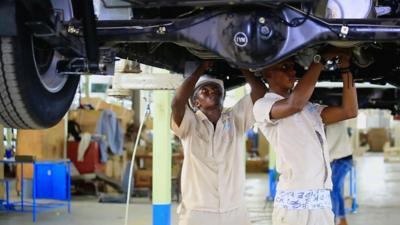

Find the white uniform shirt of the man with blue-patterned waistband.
xmin=253 ymin=93 xmax=332 ymax=191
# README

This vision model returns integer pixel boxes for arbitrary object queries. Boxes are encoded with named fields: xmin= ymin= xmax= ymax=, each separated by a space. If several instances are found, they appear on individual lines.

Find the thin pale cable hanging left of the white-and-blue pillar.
xmin=124 ymin=94 xmax=151 ymax=225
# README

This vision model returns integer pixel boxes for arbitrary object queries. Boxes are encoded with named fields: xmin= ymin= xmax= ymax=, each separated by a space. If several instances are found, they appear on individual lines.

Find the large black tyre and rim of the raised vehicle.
xmin=0 ymin=0 xmax=80 ymax=129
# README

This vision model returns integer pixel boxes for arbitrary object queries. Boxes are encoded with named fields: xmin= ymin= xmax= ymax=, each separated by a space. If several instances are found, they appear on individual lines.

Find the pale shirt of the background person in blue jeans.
xmin=325 ymin=121 xmax=352 ymax=162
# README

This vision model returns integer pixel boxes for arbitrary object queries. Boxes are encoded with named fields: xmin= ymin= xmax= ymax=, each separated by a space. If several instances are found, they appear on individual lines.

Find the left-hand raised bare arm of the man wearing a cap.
xmin=171 ymin=62 xmax=211 ymax=126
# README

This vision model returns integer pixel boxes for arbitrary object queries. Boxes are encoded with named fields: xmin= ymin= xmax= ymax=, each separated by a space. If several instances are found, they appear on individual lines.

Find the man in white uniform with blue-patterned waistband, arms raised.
xmin=253 ymin=49 xmax=358 ymax=225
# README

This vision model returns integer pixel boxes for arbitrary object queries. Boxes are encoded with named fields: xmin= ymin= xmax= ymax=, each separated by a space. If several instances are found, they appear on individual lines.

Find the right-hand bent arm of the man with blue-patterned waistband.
xmin=321 ymin=71 xmax=358 ymax=125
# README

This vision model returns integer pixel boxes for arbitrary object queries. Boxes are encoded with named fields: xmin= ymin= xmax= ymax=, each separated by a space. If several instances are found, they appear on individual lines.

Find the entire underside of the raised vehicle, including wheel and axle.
xmin=0 ymin=0 xmax=400 ymax=128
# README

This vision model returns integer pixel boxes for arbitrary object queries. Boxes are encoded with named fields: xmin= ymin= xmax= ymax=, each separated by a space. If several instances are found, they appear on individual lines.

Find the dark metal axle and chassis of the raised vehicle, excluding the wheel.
xmin=0 ymin=0 xmax=400 ymax=128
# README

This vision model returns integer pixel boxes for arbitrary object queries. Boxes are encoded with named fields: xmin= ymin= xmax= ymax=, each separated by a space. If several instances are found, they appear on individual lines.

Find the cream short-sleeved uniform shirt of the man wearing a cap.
xmin=172 ymin=96 xmax=255 ymax=212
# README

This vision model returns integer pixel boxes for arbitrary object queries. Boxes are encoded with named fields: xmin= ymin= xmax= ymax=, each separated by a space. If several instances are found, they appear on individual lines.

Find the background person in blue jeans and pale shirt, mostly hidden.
xmin=325 ymin=121 xmax=353 ymax=225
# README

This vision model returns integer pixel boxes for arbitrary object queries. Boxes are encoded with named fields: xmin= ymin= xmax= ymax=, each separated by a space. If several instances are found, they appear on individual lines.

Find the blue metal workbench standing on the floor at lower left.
xmin=0 ymin=160 xmax=71 ymax=222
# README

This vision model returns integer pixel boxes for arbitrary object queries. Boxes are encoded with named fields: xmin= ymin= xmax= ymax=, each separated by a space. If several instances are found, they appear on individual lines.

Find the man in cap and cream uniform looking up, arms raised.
xmin=171 ymin=62 xmax=266 ymax=225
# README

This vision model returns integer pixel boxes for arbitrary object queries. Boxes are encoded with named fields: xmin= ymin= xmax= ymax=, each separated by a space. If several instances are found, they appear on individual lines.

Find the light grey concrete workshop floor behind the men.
xmin=0 ymin=153 xmax=400 ymax=225
